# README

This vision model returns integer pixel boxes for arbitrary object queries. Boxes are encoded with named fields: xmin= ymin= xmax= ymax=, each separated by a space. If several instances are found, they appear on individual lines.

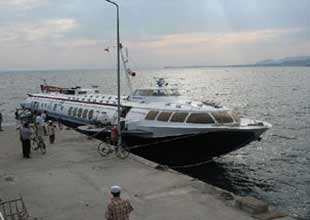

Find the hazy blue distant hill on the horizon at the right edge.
xmin=255 ymin=56 xmax=310 ymax=66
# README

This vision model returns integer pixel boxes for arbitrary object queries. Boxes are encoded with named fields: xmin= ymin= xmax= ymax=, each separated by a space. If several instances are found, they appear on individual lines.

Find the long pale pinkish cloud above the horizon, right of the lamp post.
xmin=126 ymin=28 xmax=304 ymax=65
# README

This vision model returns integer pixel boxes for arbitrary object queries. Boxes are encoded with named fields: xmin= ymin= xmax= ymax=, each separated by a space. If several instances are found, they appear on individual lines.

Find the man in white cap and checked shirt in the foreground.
xmin=105 ymin=186 xmax=133 ymax=220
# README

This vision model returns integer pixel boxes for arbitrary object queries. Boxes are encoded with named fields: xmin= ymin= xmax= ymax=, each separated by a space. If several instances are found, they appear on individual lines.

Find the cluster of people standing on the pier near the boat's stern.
xmin=20 ymin=112 xmax=56 ymax=158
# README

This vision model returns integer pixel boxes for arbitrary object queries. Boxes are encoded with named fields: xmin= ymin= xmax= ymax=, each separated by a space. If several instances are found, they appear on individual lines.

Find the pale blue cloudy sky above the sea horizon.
xmin=0 ymin=0 xmax=310 ymax=70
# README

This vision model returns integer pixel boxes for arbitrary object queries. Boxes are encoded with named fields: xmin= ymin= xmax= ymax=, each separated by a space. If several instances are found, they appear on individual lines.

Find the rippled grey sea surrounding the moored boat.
xmin=0 ymin=67 xmax=310 ymax=219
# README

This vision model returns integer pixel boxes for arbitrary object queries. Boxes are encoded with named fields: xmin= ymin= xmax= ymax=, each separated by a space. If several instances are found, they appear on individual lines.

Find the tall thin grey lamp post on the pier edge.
xmin=105 ymin=0 xmax=122 ymax=146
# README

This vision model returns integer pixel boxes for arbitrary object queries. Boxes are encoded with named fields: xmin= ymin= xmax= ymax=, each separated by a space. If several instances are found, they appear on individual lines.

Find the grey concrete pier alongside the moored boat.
xmin=0 ymin=127 xmax=291 ymax=220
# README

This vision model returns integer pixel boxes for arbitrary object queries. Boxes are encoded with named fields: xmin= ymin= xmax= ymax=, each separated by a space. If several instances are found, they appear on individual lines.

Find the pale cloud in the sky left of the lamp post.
xmin=0 ymin=18 xmax=78 ymax=46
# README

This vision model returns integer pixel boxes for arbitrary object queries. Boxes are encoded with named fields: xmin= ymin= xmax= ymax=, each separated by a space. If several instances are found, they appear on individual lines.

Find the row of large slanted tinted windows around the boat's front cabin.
xmin=145 ymin=111 xmax=234 ymax=124
